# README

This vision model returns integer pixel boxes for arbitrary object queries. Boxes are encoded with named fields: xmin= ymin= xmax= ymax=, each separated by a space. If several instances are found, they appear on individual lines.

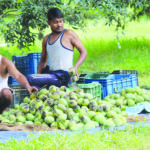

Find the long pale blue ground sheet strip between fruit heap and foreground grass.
xmin=0 ymin=121 xmax=150 ymax=144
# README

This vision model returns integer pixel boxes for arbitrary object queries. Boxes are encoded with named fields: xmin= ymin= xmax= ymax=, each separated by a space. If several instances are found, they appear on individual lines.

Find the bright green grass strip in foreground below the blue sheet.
xmin=0 ymin=126 xmax=150 ymax=150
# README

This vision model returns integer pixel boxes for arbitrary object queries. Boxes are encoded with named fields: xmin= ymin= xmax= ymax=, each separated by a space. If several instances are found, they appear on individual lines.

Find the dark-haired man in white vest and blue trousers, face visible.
xmin=28 ymin=8 xmax=87 ymax=88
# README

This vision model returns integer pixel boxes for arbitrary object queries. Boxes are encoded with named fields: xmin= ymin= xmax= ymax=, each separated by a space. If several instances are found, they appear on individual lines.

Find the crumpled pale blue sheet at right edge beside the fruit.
xmin=126 ymin=102 xmax=150 ymax=115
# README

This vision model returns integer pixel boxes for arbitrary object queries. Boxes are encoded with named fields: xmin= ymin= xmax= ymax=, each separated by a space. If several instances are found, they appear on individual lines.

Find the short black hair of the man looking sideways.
xmin=47 ymin=7 xmax=63 ymax=21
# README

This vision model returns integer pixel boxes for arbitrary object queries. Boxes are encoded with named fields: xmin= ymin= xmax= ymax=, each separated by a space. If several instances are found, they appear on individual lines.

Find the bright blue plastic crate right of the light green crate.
xmin=85 ymin=74 xmax=138 ymax=99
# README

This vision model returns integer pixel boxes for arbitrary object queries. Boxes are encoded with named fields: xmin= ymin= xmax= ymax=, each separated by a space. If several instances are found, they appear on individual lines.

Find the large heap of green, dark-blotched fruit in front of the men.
xmin=0 ymin=85 xmax=127 ymax=130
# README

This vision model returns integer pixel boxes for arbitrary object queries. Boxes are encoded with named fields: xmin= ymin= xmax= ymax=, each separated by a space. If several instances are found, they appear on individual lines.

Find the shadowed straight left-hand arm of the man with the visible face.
xmin=37 ymin=35 xmax=48 ymax=74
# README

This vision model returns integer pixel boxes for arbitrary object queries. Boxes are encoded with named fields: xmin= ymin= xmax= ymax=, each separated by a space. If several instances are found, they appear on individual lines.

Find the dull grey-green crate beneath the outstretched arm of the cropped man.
xmin=10 ymin=85 xmax=30 ymax=108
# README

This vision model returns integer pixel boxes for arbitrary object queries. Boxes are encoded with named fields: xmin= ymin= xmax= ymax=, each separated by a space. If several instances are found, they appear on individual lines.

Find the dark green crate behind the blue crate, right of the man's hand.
xmin=85 ymin=71 xmax=110 ymax=79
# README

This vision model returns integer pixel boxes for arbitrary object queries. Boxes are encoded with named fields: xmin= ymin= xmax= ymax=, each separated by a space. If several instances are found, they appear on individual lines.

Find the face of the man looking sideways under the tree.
xmin=48 ymin=18 xmax=64 ymax=33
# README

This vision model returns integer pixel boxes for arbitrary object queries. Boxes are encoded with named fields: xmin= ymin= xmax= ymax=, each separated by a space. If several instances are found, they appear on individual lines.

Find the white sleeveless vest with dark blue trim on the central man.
xmin=47 ymin=29 xmax=73 ymax=71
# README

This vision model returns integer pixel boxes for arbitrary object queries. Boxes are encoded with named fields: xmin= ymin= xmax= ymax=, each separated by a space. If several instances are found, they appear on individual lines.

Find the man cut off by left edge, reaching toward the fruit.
xmin=0 ymin=55 xmax=38 ymax=114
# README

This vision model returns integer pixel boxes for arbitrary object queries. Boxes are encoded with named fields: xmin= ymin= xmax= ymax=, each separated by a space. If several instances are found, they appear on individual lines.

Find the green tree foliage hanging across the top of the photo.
xmin=0 ymin=0 xmax=150 ymax=48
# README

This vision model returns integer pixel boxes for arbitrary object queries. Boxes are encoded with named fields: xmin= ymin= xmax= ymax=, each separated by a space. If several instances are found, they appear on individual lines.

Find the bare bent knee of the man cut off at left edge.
xmin=1 ymin=88 xmax=12 ymax=104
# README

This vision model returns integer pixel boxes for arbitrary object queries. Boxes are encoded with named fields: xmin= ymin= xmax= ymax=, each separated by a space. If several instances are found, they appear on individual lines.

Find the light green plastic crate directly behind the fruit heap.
xmin=77 ymin=83 xmax=102 ymax=98
